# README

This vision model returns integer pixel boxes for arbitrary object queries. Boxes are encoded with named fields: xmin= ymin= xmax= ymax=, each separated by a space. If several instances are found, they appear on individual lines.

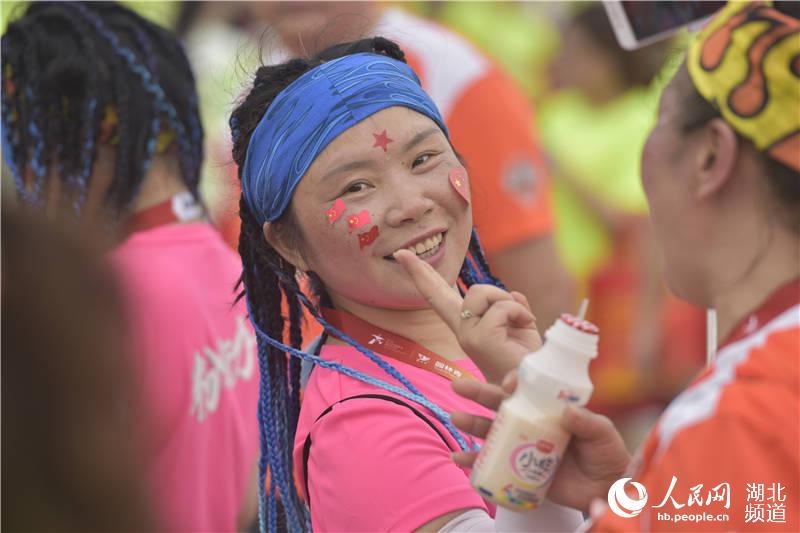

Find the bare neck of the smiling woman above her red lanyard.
xmin=328 ymin=295 xmax=467 ymax=361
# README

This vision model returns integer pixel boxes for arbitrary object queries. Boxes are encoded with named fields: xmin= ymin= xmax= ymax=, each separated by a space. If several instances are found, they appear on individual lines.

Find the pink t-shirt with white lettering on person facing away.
xmin=111 ymin=223 xmax=258 ymax=532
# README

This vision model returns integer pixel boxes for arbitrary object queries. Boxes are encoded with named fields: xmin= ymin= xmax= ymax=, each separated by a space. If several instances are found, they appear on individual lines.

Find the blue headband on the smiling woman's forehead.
xmin=242 ymin=53 xmax=449 ymax=224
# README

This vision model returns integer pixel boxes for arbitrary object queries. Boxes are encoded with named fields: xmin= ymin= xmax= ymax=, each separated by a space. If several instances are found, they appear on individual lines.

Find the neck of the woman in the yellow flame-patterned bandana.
xmin=711 ymin=224 xmax=800 ymax=342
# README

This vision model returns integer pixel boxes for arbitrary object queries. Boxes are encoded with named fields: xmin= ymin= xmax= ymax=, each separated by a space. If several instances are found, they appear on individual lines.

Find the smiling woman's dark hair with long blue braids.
xmin=230 ymin=37 xmax=502 ymax=532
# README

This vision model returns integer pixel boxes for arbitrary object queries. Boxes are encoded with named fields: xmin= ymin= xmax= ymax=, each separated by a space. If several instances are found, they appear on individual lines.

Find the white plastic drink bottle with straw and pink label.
xmin=471 ymin=314 xmax=598 ymax=511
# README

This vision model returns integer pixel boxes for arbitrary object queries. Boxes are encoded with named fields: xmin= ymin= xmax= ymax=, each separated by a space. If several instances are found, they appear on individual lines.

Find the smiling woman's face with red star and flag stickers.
xmin=274 ymin=106 xmax=472 ymax=312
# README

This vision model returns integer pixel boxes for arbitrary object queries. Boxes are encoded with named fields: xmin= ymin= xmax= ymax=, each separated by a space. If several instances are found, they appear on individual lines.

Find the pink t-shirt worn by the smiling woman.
xmin=294 ymin=345 xmax=494 ymax=533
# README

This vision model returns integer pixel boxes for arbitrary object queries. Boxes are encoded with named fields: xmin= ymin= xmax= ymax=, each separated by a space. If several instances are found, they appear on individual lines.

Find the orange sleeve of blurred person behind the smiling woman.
xmin=447 ymin=69 xmax=553 ymax=254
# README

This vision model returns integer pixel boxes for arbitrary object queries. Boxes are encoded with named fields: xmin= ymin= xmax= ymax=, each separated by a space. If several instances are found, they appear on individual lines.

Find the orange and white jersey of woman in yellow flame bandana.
xmin=593 ymin=280 xmax=800 ymax=532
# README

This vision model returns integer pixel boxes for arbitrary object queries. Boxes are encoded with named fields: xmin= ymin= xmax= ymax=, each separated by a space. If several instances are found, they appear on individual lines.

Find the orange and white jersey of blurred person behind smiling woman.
xmin=373 ymin=9 xmax=553 ymax=255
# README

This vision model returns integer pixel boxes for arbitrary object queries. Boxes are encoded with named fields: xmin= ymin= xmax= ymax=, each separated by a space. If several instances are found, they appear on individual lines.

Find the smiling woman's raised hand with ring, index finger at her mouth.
xmin=394 ymin=250 xmax=542 ymax=383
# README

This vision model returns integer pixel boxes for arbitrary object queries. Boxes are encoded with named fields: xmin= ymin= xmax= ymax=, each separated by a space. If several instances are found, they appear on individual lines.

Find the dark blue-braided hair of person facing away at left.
xmin=2 ymin=2 xmax=203 ymax=214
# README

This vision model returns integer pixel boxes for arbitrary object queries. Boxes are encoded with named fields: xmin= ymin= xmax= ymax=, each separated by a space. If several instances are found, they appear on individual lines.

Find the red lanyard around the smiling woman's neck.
xmin=322 ymin=308 xmax=478 ymax=381
